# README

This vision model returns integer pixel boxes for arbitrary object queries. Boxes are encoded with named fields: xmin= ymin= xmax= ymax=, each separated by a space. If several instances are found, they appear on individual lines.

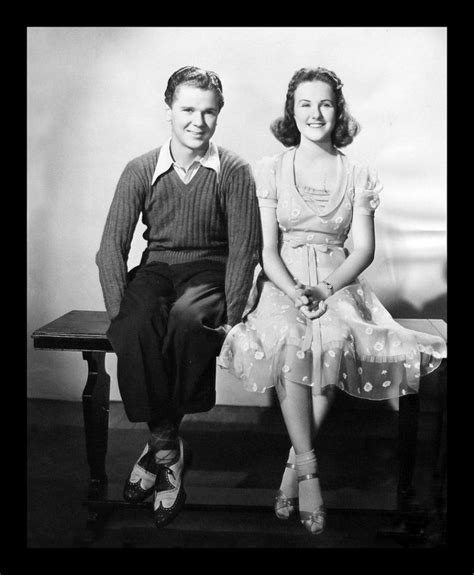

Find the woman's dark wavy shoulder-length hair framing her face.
xmin=270 ymin=68 xmax=360 ymax=148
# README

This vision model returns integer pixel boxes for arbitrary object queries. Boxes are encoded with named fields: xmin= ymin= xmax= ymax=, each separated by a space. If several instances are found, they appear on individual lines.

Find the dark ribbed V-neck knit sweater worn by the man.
xmin=96 ymin=146 xmax=261 ymax=325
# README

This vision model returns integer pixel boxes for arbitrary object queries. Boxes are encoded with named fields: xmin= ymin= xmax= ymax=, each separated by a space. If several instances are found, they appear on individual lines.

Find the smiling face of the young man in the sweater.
xmin=167 ymin=84 xmax=219 ymax=153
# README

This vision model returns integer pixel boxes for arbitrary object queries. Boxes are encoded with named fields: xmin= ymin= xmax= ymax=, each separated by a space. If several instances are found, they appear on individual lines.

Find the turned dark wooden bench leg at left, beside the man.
xmin=82 ymin=351 xmax=110 ymax=499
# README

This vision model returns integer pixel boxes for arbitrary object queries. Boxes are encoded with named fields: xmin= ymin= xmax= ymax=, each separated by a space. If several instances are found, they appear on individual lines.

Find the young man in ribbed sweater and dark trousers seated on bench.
xmin=96 ymin=66 xmax=261 ymax=526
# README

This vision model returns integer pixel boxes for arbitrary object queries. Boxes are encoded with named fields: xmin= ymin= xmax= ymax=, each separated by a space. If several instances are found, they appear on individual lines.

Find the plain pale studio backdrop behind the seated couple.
xmin=27 ymin=27 xmax=447 ymax=405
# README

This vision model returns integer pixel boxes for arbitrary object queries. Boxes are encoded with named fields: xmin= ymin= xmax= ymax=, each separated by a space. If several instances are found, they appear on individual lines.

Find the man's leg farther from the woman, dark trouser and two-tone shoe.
xmin=108 ymin=263 xmax=186 ymax=502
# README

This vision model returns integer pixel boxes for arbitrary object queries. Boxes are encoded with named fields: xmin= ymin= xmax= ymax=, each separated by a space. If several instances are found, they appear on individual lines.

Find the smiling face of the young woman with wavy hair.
xmin=294 ymin=80 xmax=336 ymax=143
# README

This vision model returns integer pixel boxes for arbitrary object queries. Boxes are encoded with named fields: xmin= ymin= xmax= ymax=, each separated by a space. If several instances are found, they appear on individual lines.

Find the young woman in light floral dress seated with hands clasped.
xmin=218 ymin=68 xmax=446 ymax=534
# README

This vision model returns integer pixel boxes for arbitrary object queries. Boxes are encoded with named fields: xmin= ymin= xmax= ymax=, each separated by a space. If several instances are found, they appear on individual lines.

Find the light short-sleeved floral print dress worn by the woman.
xmin=218 ymin=148 xmax=447 ymax=400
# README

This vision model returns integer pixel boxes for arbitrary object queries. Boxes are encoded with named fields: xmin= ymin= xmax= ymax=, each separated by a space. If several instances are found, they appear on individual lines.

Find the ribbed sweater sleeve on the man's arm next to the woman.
xmin=225 ymin=165 xmax=261 ymax=326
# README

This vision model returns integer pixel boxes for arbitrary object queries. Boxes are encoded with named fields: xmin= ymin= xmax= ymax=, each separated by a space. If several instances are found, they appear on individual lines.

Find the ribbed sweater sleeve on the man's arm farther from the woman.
xmin=96 ymin=162 xmax=146 ymax=319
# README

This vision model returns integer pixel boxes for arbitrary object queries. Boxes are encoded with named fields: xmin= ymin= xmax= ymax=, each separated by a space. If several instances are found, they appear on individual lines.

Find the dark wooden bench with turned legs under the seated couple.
xmin=31 ymin=310 xmax=447 ymax=544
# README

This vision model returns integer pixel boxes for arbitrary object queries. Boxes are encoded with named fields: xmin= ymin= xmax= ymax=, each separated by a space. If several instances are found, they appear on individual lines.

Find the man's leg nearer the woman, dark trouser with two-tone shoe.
xmin=153 ymin=262 xmax=225 ymax=527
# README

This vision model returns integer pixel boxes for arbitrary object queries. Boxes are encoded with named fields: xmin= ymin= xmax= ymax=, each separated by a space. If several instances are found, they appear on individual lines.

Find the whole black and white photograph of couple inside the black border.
xmin=25 ymin=26 xmax=448 ymax=555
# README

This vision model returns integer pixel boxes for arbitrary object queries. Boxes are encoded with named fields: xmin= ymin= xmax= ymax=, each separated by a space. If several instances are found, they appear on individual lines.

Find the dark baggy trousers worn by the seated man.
xmin=107 ymin=261 xmax=226 ymax=422
